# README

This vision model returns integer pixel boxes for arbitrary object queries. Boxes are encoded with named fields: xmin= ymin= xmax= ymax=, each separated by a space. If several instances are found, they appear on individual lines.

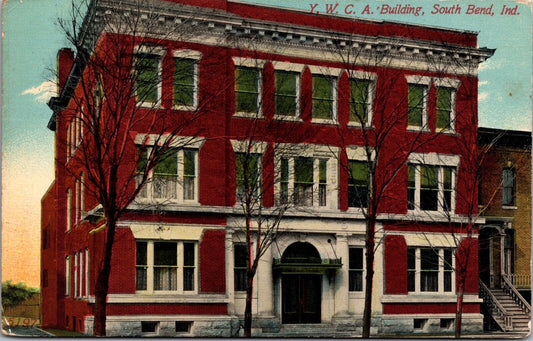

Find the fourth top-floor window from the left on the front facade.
xmin=274 ymin=70 xmax=299 ymax=117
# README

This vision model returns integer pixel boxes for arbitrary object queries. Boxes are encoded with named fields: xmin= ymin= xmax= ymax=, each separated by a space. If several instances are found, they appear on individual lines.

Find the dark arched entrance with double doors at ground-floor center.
xmin=280 ymin=242 xmax=323 ymax=323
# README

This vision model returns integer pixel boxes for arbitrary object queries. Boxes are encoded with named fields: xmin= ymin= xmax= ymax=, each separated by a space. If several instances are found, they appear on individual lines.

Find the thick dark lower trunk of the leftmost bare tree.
xmin=93 ymin=218 xmax=116 ymax=337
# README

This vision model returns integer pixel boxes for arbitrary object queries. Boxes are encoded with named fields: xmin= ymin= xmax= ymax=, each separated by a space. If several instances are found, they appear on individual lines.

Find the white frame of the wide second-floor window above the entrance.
xmin=274 ymin=143 xmax=340 ymax=209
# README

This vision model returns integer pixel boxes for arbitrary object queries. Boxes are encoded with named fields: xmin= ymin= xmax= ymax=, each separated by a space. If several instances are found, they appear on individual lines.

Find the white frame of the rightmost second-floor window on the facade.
xmin=406 ymin=153 xmax=460 ymax=216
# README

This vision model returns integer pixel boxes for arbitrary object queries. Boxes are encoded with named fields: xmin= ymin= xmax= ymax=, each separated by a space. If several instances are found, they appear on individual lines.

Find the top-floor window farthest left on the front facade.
xmin=135 ymin=52 xmax=162 ymax=105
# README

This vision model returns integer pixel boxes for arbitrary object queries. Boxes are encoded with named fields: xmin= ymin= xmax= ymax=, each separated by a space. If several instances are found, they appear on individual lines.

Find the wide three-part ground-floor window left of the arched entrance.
xmin=136 ymin=241 xmax=198 ymax=293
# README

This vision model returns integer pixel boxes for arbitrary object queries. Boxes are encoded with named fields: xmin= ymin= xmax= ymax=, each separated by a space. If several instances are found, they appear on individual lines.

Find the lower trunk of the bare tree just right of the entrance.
xmin=362 ymin=217 xmax=376 ymax=339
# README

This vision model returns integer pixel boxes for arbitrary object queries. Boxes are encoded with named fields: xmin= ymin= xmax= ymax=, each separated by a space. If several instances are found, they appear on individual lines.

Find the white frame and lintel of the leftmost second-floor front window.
xmin=135 ymin=134 xmax=205 ymax=205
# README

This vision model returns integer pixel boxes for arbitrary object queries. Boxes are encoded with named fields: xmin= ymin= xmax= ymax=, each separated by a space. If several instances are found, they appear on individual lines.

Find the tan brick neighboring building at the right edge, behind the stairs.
xmin=478 ymin=128 xmax=531 ymax=300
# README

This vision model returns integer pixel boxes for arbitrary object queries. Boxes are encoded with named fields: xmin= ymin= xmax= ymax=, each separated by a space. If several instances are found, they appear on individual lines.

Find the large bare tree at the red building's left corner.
xmin=49 ymin=0 xmax=224 ymax=336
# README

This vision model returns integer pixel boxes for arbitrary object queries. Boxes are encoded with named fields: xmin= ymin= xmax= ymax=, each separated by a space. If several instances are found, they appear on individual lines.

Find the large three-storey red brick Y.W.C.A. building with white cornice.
xmin=41 ymin=0 xmax=493 ymax=336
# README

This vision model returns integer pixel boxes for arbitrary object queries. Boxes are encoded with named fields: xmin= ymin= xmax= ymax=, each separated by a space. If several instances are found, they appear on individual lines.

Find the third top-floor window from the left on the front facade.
xmin=235 ymin=66 xmax=260 ymax=114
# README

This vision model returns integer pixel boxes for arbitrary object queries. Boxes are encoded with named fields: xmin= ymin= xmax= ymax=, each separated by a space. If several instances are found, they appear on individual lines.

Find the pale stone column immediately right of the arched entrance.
xmin=335 ymin=234 xmax=350 ymax=317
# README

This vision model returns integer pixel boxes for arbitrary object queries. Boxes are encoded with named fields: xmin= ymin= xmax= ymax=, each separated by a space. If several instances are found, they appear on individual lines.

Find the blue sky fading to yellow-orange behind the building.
xmin=2 ymin=0 xmax=532 ymax=282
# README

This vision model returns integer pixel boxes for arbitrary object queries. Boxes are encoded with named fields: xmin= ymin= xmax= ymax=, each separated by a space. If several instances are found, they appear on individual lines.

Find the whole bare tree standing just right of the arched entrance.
xmin=324 ymin=29 xmax=491 ymax=338
